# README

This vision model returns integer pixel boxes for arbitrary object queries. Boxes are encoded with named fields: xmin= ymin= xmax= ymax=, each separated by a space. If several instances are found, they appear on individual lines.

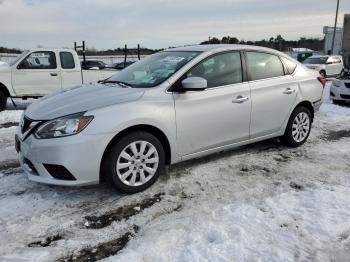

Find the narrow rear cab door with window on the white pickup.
xmin=59 ymin=51 xmax=82 ymax=89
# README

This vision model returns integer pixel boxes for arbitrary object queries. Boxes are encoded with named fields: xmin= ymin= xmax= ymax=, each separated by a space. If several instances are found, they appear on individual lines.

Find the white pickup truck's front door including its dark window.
xmin=12 ymin=51 xmax=61 ymax=96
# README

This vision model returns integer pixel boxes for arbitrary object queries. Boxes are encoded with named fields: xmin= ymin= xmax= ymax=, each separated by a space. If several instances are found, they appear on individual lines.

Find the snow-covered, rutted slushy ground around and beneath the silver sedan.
xmin=0 ymin=85 xmax=350 ymax=261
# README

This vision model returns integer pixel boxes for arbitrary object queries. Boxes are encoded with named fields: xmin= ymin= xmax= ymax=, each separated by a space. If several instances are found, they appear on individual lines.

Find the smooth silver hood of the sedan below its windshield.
xmin=25 ymin=84 xmax=144 ymax=120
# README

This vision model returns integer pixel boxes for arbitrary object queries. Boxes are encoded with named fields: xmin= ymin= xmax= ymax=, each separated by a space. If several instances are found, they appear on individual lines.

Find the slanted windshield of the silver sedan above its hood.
xmin=106 ymin=51 xmax=199 ymax=87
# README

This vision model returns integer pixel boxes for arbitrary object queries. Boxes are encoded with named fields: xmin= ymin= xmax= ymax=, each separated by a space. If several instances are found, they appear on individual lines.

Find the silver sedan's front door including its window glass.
xmin=174 ymin=52 xmax=251 ymax=157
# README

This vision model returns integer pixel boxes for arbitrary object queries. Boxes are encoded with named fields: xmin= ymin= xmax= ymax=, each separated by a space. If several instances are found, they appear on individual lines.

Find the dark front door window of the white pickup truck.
xmin=18 ymin=51 xmax=57 ymax=69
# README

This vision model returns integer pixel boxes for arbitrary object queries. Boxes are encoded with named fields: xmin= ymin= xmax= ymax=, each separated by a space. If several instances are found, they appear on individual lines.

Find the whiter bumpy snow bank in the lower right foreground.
xmin=106 ymin=185 xmax=350 ymax=262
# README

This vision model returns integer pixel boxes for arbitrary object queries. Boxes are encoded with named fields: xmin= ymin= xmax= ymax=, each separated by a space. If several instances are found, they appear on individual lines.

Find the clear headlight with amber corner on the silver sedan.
xmin=34 ymin=113 xmax=94 ymax=139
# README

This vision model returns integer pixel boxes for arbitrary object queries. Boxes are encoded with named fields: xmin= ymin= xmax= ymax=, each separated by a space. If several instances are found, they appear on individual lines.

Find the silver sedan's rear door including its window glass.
xmin=245 ymin=51 xmax=298 ymax=138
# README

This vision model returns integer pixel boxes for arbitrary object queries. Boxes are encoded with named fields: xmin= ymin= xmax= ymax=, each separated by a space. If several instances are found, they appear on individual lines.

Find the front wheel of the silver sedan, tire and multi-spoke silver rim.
xmin=102 ymin=131 xmax=165 ymax=194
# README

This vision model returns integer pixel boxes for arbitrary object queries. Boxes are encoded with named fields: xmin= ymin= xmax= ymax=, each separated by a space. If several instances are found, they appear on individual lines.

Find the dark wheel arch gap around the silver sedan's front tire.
xmin=100 ymin=124 xmax=171 ymax=182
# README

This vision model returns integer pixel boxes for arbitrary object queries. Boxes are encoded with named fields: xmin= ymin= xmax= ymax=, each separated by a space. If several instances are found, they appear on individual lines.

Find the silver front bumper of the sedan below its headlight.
xmin=16 ymin=133 xmax=110 ymax=186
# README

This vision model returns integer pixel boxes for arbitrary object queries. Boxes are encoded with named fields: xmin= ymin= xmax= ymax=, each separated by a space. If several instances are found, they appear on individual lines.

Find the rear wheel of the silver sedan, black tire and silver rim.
xmin=282 ymin=106 xmax=312 ymax=147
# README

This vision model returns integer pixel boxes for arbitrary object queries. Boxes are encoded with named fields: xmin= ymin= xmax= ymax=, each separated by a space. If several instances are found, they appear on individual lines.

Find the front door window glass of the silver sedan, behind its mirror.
xmin=187 ymin=52 xmax=242 ymax=88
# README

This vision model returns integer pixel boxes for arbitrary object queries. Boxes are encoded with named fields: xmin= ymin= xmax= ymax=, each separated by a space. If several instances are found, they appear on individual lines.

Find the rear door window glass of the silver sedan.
xmin=247 ymin=52 xmax=284 ymax=80
